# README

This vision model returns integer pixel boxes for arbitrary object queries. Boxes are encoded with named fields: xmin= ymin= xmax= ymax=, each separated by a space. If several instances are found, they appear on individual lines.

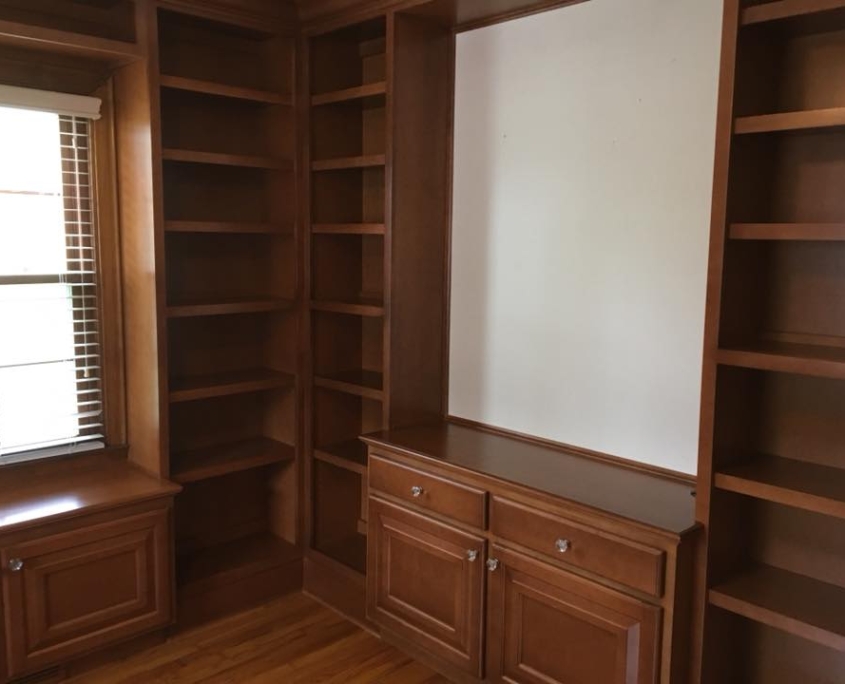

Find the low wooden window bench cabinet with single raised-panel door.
xmin=0 ymin=449 xmax=176 ymax=681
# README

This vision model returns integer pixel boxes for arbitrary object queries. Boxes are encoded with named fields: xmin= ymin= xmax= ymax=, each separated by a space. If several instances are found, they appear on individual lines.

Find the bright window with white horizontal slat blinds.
xmin=0 ymin=101 xmax=103 ymax=463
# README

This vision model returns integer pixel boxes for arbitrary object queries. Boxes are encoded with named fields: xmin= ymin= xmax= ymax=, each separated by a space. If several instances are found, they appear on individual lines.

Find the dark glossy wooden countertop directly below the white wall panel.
xmin=361 ymin=423 xmax=696 ymax=535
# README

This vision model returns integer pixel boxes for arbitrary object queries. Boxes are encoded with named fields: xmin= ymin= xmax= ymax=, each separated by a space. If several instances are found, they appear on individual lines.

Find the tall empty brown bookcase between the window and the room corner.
xmin=157 ymin=3 xmax=302 ymax=624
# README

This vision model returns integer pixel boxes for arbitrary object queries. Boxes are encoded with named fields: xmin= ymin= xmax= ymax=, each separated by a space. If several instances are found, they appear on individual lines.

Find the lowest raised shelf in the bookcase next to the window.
xmin=171 ymin=437 xmax=295 ymax=484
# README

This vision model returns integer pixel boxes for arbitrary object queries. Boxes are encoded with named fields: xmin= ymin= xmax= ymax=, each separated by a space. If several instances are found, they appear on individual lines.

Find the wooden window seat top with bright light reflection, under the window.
xmin=0 ymin=453 xmax=181 ymax=533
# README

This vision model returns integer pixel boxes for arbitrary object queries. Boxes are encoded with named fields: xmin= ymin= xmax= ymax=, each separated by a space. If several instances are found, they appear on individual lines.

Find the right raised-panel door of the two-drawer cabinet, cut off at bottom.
xmin=487 ymin=546 xmax=660 ymax=684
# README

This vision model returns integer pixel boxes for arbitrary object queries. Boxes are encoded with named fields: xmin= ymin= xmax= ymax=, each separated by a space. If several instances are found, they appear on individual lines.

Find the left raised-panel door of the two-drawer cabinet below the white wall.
xmin=367 ymin=498 xmax=486 ymax=677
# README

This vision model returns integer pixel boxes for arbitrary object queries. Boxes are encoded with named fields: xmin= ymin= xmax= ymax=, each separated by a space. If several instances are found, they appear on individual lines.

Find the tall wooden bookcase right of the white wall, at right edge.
xmin=698 ymin=0 xmax=845 ymax=684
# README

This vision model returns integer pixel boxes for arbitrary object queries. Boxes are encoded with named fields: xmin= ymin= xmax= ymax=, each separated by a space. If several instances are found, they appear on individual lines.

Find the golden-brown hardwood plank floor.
xmin=68 ymin=594 xmax=448 ymax=684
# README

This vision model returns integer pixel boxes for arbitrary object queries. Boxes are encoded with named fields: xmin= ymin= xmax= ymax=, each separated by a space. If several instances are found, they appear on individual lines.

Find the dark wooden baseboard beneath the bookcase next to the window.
xmin=177 ymin=560 xmax=302 ymax=630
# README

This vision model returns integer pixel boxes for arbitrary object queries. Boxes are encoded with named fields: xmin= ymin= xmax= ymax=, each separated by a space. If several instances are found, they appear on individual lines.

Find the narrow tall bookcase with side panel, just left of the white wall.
xmin=302 ymin=13 xmax=453 ymax=621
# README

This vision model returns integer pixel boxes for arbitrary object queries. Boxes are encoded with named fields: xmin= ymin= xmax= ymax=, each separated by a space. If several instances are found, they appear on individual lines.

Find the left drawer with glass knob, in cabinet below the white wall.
xmin=370 ymin=454 xmax=487 ymax=529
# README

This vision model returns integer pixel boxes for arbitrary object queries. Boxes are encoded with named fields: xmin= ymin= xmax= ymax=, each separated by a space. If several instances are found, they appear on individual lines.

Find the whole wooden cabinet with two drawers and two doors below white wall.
xmin=362 ymin=423 xmax=698 ymax=684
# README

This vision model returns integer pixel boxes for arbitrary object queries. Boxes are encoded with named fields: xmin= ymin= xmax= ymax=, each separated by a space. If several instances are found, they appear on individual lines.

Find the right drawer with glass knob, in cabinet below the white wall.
xmin=490 ymin=497 xmax=665 ymax=597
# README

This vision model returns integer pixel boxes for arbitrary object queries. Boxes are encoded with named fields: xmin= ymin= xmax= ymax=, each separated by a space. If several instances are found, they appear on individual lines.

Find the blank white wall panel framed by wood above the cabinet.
xmin=449 ymin=0 xmax=722 ymax=473
